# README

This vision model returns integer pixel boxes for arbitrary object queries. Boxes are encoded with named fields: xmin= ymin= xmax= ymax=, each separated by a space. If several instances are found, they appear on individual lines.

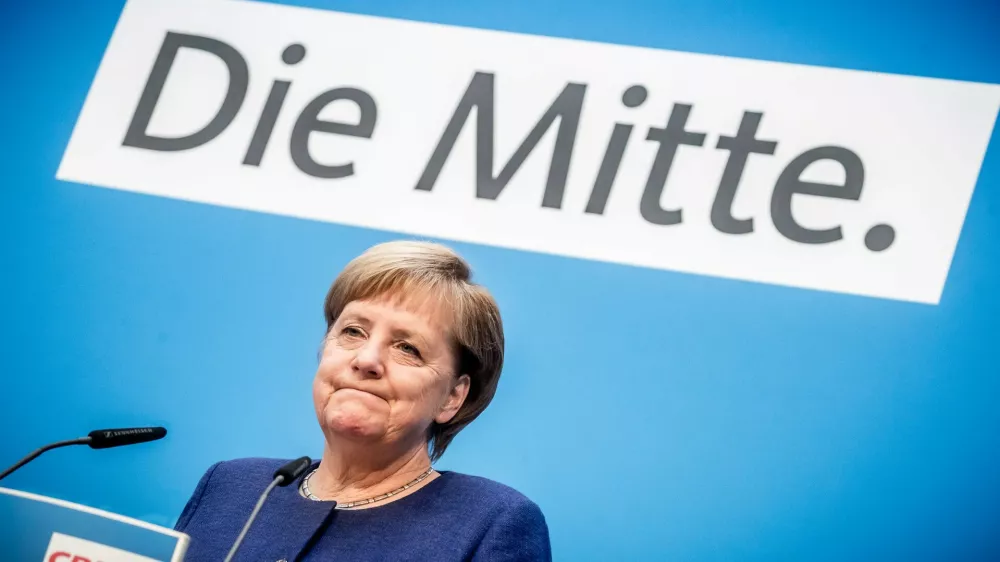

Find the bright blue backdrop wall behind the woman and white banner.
xmin=0 ymin=0 xmax=1000 ymax=561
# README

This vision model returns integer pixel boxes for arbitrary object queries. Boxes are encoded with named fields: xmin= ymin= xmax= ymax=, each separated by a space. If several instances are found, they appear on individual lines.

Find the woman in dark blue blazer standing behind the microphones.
xmin=176 ymin=242 xmax=551 ymax=562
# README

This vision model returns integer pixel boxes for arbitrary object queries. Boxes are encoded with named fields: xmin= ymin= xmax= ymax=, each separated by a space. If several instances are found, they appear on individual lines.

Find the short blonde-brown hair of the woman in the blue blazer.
xmin=324 ymin=240 xmax=504 ymax=460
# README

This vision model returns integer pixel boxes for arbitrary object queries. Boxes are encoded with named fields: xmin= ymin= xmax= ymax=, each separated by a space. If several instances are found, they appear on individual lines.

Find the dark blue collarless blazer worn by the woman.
xmin=175 ymin=459 xmax=552 ymax=562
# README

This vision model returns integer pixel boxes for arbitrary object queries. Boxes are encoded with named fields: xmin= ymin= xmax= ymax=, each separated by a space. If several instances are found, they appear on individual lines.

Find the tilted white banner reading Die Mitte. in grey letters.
xmin=58 ymin=0 xmax=1000 ymax=304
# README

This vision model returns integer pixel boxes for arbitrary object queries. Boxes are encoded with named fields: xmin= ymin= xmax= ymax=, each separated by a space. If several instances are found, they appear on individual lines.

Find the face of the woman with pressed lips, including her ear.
xmin=313 ymin=298 xmax=469 ymax=445
